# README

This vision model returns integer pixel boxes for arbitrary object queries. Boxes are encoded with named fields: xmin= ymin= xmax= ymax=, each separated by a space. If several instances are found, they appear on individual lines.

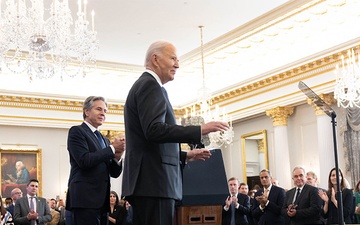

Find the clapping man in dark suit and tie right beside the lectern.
xmin=222 ymin=177 xmax=250 ymax=225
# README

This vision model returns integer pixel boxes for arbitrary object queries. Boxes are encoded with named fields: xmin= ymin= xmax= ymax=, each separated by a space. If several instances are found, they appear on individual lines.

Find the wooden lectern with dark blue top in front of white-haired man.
xmin=176 ymin=149 xmax=229 ymax=225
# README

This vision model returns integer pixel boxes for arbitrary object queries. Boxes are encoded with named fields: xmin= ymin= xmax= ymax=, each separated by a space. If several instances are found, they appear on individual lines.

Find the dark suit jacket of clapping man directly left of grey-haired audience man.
xmin=252 ymin=185 xmax=285 ymax=225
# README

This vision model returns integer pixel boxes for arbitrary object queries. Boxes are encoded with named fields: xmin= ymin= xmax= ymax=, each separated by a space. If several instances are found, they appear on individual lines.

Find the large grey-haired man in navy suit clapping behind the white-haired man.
xmin=66 ymin=96 xmax=125 ymax=225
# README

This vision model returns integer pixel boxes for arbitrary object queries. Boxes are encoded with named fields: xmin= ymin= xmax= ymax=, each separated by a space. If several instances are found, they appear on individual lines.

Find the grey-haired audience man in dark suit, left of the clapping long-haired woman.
xmin=282 ymin=167 xmax=322 ymax=225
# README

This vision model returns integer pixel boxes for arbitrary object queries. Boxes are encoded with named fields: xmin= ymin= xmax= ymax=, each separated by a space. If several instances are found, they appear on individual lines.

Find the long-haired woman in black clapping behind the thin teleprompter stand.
xmin=319 ymin=168 xmax=354 ymax=224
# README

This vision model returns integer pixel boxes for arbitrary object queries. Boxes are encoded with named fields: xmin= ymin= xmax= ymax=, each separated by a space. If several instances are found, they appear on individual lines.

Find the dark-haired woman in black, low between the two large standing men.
xmin=109 ymin=191 xmax=126 ymax=225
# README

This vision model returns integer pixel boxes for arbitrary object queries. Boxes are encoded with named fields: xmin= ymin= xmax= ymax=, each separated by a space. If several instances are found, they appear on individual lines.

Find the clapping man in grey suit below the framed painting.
xmin=14 ymin=179 xmax=51 ymax=225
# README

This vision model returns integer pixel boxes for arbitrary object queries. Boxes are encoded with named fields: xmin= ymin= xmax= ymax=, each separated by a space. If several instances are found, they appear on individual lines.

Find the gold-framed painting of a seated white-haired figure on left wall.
xmin=0 ymin=148 xmax=42 ymax=198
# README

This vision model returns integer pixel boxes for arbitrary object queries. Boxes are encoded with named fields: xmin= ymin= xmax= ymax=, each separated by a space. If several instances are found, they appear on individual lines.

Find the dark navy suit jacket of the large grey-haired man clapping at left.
xmin=66 ymin=123 xmax=122 ymax=212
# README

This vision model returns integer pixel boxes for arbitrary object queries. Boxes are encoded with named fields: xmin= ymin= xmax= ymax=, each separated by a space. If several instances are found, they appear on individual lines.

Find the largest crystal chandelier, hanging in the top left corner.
xmin=0 ymin=0 xmax=99 ymax=81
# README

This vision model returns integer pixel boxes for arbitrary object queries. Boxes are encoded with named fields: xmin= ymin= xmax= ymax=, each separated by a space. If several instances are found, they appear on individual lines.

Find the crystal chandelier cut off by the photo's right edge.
xmin=334 ymin=49 xmax=360 ymax=108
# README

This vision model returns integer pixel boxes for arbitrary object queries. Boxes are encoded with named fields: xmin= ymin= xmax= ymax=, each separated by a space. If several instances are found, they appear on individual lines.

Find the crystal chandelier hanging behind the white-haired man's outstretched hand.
xmin=181 ymin=26 xmax=234 ymax=149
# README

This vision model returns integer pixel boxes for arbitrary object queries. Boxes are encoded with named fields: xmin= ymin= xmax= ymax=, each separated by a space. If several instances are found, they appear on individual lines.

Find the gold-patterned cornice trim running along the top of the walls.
xmin=0 ymin=43 xmax=360 ymax=117
